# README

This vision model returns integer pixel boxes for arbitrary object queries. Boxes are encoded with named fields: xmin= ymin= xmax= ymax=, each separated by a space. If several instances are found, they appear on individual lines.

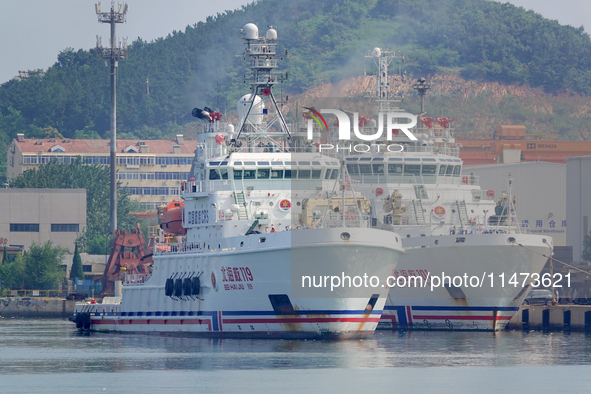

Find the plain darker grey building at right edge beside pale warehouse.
xmin=565 ymin=156 xmax=591 ymax=261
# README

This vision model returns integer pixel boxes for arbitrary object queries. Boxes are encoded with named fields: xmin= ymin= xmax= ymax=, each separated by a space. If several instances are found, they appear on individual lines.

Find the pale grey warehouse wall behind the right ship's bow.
xmin=463 ymin=159 xmax=568 ymax=245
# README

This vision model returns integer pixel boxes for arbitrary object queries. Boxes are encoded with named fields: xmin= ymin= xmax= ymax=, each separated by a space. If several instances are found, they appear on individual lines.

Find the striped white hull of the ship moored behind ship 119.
xmin=379 ymin=234 xmax=552 ymax=331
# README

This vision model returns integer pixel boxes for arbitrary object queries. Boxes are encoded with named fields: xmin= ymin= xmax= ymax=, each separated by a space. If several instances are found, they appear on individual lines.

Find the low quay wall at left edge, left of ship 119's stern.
xmin=0 ymin=297 xmax=76 ymax=318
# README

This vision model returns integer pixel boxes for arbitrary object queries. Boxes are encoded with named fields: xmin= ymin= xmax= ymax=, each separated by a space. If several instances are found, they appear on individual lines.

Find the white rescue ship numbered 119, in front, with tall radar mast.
xmin=75 ymin=24 xmax=403 ymax=339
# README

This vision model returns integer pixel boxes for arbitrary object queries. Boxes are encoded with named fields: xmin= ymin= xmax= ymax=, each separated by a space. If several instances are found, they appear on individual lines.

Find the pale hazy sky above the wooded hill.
xmin=0 ymin=0 xmax=591 ymax=83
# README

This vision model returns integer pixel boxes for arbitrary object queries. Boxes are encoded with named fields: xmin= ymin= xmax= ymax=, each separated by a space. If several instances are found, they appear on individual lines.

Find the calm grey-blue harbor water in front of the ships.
xmin=0 ymin=318 xmax=591 ymax=393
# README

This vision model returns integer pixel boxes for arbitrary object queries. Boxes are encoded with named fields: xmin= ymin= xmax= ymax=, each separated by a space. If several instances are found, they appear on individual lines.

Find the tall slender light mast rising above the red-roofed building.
xmin=94 ymin=1 xmax=129 ymax=232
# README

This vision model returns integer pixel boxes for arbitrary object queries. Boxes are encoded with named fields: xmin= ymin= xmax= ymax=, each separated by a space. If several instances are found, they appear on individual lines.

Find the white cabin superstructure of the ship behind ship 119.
xmin=345 ymin=152 xmax=517 ymax=236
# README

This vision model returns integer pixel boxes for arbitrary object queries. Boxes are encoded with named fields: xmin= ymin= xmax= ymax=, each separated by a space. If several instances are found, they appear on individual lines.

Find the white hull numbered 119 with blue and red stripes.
xmin=76 ymin=228 xmax=403 ymax=339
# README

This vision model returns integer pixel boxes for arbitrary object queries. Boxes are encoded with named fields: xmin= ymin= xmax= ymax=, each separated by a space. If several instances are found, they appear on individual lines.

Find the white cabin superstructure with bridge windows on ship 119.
xmin=181 ymin=152 xmax=359 ymax=243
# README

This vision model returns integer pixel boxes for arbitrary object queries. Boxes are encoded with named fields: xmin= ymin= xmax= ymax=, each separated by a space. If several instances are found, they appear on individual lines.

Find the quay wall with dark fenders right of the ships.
xmin=506 ymin=305 xmax=591 ymax=331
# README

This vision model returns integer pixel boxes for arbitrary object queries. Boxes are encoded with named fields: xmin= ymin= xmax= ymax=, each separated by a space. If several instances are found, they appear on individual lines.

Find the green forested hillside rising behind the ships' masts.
xmin=0 ymin=0 xmax=591 ymax=180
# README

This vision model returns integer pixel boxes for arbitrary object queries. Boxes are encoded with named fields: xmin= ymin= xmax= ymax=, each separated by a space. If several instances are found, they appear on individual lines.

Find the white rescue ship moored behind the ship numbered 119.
xmin=310 ymin=48 xmax=553 ymax=330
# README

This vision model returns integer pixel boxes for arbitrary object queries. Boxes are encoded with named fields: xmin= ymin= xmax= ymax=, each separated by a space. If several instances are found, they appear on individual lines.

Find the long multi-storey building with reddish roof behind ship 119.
xmin=6 ymin=134 xmax=197 ymax=209
